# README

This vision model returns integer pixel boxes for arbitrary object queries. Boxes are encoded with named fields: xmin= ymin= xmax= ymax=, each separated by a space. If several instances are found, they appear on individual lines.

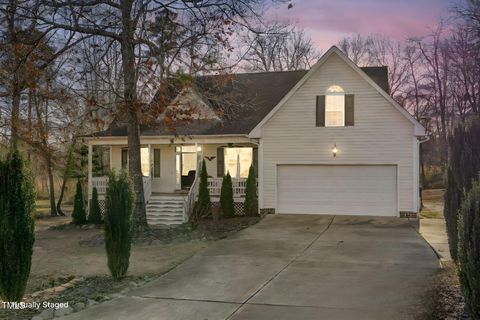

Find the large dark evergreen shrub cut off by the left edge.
xmin=0 ymin=150 xmax=35 ymax=301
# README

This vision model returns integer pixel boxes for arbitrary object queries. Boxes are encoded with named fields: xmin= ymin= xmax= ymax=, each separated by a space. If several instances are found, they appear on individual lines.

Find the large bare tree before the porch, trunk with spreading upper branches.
xmin=36 ymin=0 xmax=278 ymax=230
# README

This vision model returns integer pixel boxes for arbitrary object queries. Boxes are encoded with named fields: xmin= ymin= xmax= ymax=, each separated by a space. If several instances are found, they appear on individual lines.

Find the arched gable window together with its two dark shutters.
xmin=316 ymin=85 xmax=354 ymax=127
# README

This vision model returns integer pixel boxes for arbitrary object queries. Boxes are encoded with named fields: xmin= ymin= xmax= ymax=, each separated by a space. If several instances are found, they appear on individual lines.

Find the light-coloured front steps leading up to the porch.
xmin=147 ymin=194 xmax=184 ymax=225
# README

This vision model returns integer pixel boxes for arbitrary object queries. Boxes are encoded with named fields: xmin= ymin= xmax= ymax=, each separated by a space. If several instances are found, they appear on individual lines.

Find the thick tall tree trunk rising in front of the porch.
xmin=121 ymin=0 xmax=148 ymax=233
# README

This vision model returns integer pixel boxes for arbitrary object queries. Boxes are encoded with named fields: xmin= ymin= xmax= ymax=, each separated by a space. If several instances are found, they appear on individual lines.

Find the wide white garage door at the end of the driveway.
xmin=277 ymin=165 xmax=397 ymax=216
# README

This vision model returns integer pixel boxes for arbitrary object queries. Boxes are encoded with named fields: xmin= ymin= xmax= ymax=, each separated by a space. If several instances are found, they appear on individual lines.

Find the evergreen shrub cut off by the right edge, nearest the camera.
xmin=458 ymin=183 xmax=480 ymax=319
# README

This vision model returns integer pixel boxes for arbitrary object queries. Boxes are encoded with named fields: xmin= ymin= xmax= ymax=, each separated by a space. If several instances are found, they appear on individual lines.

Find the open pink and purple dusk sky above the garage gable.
xmin=267 ymin=0 xmax=458 ymax=51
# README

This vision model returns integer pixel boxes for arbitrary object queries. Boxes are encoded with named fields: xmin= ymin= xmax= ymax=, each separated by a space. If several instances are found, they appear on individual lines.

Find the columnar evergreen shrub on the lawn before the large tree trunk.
xmin=104 ymin=171 xmax=134 ymax=280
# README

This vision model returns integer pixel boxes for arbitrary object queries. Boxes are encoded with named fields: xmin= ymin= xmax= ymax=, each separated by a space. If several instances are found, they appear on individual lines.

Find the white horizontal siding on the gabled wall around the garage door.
xmin=260 ymin=54 xmax=417 ymax=211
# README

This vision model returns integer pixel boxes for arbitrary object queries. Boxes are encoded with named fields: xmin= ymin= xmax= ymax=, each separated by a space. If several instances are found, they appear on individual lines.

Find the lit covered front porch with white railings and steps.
xmin=88 ymin=140 xmax=257 ymax=224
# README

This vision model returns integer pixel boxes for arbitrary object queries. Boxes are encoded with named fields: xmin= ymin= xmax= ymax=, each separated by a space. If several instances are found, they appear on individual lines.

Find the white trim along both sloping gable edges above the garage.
xmin=249 ymin=46 xmax=426 ymax=138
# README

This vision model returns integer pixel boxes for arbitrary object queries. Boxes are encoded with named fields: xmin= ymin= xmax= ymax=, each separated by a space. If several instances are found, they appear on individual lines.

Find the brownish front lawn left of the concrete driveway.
xmin=0 ymin=216 xmax=259 ymax=320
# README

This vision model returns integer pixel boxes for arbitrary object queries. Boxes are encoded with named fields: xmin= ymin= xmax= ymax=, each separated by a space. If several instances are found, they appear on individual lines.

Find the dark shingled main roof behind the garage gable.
xmin=90 ymin=47 xmax=408 ymax=137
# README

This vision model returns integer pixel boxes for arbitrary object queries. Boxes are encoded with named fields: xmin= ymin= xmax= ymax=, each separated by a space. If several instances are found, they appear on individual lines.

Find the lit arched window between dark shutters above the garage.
xmin=325 ymin=86 xmax=345 ymax=127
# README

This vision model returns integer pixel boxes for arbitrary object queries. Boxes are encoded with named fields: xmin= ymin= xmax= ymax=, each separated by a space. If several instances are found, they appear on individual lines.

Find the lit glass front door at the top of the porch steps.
xmin=175 ymin=145 xmax=197 ymax=190
